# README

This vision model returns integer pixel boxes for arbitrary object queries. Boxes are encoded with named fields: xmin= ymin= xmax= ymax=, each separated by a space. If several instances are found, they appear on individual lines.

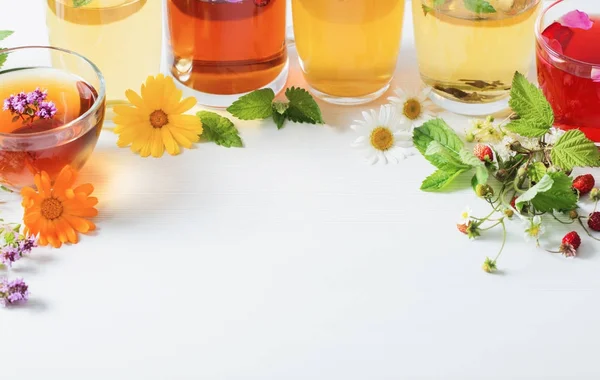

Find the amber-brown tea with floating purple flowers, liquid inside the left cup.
xmin=0 ymin=68 xmax=103 ymax=189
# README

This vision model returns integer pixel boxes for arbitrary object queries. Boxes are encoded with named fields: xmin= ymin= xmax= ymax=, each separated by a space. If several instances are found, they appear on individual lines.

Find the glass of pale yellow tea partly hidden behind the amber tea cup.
xmin=46 ymin=0 xmax=162 ymax=103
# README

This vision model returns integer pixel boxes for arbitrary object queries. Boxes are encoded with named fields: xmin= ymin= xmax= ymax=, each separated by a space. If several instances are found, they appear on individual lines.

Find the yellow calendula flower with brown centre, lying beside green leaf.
xmin=114 ymin=74 xmax=202 ymax=157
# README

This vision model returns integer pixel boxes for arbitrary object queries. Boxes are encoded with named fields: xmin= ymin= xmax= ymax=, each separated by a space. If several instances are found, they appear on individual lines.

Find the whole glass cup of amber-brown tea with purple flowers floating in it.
xmin=0 ymin=46 xmax=105 ymax=190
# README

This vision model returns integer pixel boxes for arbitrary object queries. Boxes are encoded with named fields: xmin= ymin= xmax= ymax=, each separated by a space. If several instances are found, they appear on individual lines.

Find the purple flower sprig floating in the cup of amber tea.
xmin=2 ymin=88 xmax=57 ymax=123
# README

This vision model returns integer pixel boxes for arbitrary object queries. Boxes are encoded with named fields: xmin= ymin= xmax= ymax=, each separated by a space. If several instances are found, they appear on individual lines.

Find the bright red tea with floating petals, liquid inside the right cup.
xmin=537 ymin=15 xmax=600 ymax=142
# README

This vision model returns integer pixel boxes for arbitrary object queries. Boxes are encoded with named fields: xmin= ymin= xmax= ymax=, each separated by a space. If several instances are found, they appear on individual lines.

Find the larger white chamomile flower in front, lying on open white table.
xmin=350 ymin=105 xmax=414 ymax=164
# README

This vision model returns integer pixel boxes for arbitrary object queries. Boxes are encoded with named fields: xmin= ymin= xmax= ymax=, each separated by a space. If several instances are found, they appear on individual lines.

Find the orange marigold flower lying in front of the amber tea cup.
xmin=21 ymin=166 xmax=98 ymax=248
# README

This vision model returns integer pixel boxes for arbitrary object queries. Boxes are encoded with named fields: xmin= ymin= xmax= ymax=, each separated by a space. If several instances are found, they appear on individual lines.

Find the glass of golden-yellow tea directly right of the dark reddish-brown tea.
xmin=292 ymin=0 xmax=404 ymax=105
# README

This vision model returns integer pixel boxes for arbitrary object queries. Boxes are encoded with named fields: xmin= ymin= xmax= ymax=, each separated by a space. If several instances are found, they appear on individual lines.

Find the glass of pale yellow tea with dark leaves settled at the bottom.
xmin=412 ymin=0 xmax=540 ymax=115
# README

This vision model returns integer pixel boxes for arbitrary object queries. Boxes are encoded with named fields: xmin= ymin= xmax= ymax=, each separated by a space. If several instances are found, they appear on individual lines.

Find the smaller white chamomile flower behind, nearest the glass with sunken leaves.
xmin=388 ymin=87 xmax=435 ymax=128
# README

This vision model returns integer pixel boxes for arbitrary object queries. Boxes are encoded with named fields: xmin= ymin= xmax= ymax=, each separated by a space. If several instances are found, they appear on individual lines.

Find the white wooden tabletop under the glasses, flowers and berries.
xmin=0 ymin=0 xmax=600 ymax=380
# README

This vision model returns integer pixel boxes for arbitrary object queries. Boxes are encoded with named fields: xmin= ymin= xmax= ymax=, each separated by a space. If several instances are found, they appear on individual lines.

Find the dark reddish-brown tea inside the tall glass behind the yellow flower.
xmin=167 ymin=0 xmax=287 ymax=95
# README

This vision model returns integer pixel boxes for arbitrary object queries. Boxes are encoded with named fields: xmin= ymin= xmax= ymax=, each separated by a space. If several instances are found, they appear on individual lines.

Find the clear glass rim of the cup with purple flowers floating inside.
xmin=0 ymin=45 xmax=106 ymax=140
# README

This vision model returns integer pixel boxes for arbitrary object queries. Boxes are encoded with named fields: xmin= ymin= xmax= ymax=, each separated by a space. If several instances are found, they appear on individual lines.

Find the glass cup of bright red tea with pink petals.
xmin=536 ymin=0 xmax=600 ymax=143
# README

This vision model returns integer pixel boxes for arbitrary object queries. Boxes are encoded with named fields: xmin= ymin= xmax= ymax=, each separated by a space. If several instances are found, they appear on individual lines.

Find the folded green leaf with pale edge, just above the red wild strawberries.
xmin=515 ymin=172 xmax=579 ymax=212
